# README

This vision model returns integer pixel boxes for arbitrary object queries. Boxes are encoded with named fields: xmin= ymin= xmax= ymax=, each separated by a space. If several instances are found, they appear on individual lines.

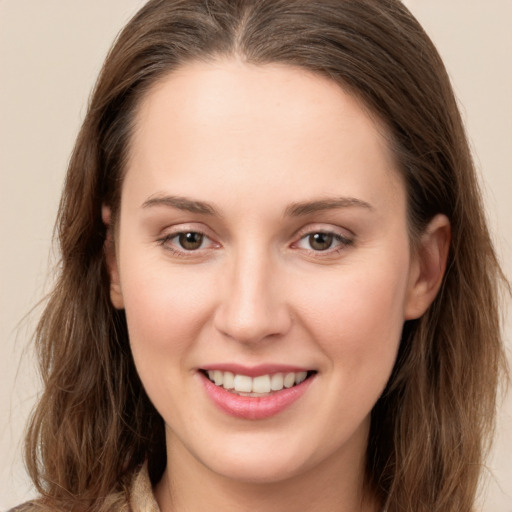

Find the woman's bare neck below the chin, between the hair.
xmin=155 ymin=428 xmax=379 ymax=512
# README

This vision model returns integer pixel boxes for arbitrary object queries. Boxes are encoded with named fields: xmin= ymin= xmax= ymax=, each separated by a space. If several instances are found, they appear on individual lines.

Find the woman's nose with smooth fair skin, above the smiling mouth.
xmin=214 ymin=247 xmax=292 ymax=344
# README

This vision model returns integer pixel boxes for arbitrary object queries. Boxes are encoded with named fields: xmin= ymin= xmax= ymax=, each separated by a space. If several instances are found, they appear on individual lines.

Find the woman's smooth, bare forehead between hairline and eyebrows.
xmin=123 ymin=60 xmax=403 ymax=216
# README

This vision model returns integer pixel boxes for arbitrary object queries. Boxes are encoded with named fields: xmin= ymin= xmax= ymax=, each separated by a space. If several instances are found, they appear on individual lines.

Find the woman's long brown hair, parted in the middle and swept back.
xmin=26 ymin=0 xmax=505 ymax=512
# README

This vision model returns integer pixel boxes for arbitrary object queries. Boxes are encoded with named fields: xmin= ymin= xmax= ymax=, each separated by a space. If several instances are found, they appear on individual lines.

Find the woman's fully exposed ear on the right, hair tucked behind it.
xmin=404 ymin=214 xmax=451 ymax=320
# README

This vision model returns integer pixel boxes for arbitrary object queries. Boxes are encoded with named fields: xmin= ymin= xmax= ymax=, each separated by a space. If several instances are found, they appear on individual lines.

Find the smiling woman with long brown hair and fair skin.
xmin=12 ymin=0 xmax=508 ymax=512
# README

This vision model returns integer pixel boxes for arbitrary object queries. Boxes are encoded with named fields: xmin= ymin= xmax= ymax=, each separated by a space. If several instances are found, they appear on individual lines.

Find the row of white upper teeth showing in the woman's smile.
xmin=208 ymin=370 xmax=308 ymax=394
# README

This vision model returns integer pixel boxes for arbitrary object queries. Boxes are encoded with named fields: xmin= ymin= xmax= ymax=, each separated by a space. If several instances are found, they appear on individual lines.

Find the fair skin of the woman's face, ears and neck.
xmin=103 ymin=60 xmax=449 ymax=512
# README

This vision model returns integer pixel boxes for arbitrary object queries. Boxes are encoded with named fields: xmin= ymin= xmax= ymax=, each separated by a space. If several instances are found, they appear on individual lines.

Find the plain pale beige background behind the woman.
xmin=0 ymin=0 xmax=512 ymax=512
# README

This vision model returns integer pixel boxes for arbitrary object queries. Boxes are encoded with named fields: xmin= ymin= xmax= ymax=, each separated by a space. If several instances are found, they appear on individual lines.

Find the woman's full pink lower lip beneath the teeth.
xmin=200 ymin=373 xmax=314 ymax=420
